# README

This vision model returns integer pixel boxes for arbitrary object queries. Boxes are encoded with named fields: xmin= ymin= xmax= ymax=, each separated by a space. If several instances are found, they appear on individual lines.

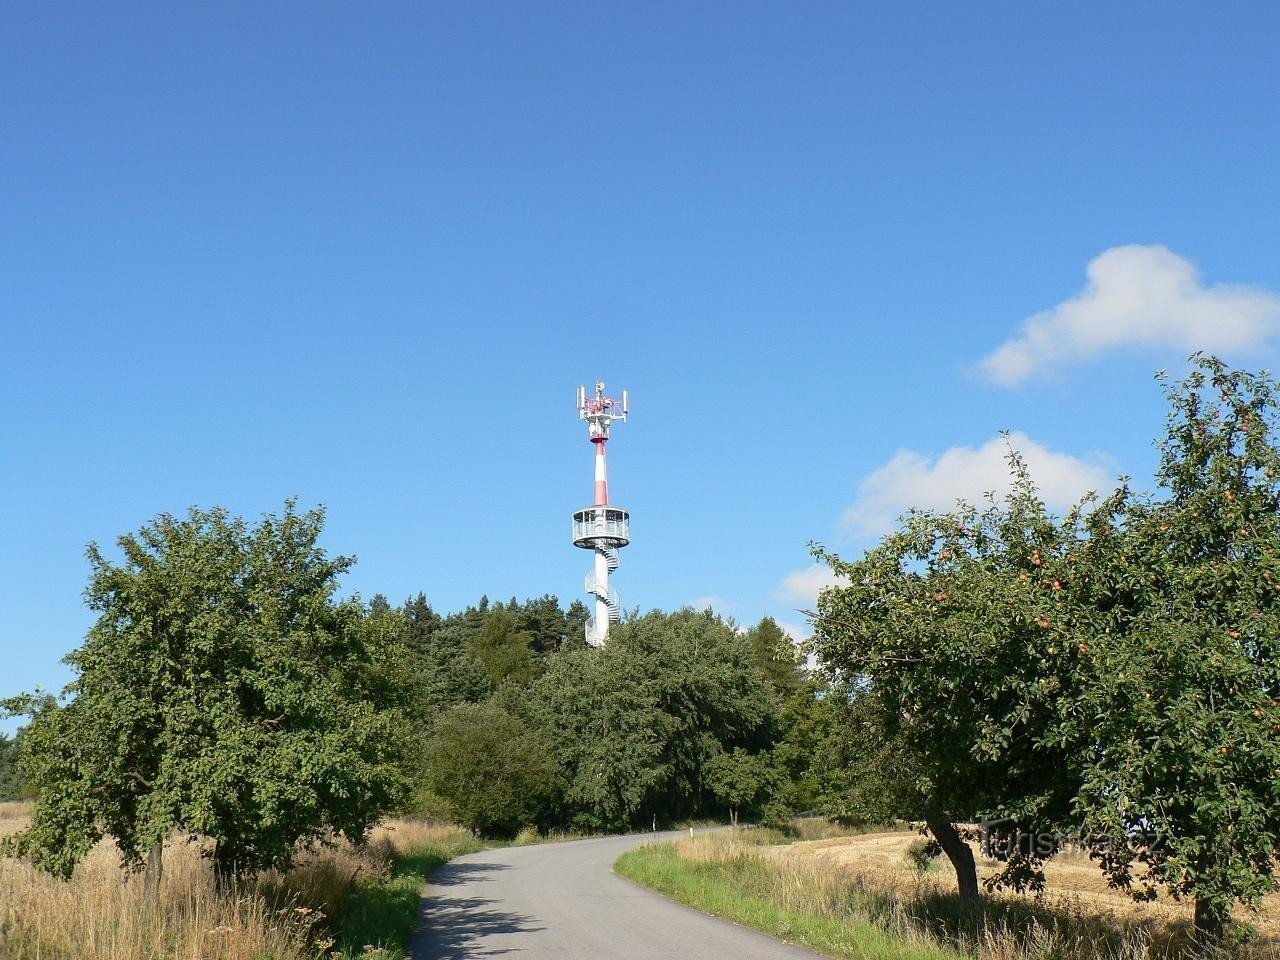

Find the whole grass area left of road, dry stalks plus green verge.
xmin=0 ymin=804 xmax=479 ymax=960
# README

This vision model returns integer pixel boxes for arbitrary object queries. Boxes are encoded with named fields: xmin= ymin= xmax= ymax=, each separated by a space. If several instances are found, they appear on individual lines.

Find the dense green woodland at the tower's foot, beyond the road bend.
xmin=389 ymin=596 xmax=831 ymax=836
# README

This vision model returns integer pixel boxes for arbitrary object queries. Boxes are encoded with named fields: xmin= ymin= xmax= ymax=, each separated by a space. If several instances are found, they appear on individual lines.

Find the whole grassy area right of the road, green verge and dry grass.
xmin=616 ymin=831 xmax=1280 ymax=960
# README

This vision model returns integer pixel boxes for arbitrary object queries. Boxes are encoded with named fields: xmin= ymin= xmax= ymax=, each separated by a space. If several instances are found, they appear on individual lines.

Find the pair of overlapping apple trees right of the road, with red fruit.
xmin=813 ymin=357 xmax=1280 ymax=938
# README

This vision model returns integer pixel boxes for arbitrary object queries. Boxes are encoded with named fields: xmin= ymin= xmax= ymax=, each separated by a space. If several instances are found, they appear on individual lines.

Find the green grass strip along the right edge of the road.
xmin=614 ymin=831 xmax=963 ymax=960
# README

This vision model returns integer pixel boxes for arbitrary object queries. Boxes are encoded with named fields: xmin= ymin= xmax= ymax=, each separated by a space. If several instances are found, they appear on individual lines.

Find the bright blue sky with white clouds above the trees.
xmin=0 ymin=3 xmax=1280 ymax=727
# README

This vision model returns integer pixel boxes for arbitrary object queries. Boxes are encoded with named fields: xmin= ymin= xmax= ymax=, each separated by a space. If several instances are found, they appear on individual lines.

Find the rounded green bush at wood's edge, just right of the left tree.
xmin=426 ymin=703 xmax=554 ymax=837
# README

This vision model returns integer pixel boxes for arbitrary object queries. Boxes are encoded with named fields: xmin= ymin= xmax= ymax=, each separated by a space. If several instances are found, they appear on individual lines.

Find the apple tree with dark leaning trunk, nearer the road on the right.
xmin=812 ymin=452 xmax=1080 ymax=905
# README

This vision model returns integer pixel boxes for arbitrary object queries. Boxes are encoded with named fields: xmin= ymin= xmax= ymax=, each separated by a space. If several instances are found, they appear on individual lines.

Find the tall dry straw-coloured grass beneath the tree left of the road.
xmin=0 ymin=804 xmax=471 ymax=960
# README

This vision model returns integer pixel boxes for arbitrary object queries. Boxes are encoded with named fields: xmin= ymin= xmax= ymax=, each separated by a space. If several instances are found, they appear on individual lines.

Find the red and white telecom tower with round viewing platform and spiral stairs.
xmin=573 ymin=380 xmax=631 ymax=646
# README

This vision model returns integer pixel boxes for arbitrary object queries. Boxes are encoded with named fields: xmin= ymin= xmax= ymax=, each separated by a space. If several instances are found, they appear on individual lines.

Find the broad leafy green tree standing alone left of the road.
xmin=10 ymin=500 xmax=412 ymax=879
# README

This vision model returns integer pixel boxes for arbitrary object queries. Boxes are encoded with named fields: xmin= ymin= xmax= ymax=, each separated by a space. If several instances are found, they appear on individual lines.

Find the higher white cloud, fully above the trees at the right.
xmin=982 ymin=244 xmax=1280 ymax=387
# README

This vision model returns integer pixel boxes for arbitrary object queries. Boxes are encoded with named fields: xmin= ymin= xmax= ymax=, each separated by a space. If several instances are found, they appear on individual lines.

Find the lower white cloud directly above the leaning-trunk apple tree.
xmin=839 ymin=433 xmax=1114 ymax=537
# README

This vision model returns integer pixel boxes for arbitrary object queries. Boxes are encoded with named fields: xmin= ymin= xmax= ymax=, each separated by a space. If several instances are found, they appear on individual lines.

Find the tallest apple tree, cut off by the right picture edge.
xmin=1061 ymin=356 xmax=1280 ymax=940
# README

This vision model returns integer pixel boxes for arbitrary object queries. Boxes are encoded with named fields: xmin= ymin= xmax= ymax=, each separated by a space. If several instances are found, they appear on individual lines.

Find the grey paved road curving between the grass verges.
xmin=410 ymin=833 xmax=818 ymax=960
